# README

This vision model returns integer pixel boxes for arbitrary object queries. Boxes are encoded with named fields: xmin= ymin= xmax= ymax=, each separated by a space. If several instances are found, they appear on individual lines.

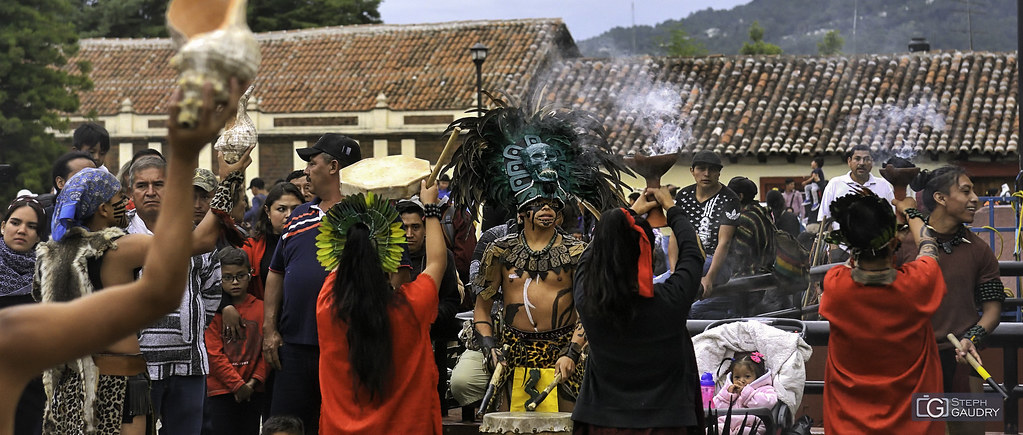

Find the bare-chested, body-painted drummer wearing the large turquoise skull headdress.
xmin=449 ymin=96 xmax=626 ymax=411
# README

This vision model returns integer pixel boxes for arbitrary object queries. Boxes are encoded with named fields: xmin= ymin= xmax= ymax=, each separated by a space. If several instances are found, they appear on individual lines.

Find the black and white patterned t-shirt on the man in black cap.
xmin=675 ymin=184 xmax=742 ymax=255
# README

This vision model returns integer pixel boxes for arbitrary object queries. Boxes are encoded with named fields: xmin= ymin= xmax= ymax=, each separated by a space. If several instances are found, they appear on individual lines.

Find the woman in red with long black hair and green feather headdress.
xmin=316 ymin=182 xmax=447 ymax=429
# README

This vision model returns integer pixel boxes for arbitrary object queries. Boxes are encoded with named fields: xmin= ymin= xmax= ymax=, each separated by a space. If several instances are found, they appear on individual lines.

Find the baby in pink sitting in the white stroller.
xmin=714 ymin=351 xmax=777 ymax=435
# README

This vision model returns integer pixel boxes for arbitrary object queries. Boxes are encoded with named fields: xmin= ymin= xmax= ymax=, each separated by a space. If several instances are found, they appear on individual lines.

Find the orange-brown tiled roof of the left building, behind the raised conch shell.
xmin=69 ymin=18 xmax=578 ymax=115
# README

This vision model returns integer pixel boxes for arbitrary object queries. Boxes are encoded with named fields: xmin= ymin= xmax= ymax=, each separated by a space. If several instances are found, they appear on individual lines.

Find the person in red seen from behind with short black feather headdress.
xmin=819 ymin=189 xmax=957 ymax=434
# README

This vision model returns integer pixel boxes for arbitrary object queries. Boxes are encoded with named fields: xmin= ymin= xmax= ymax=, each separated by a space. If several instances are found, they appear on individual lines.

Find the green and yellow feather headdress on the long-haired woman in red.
xmin=316 ymin=192 xmax=405 ymax=272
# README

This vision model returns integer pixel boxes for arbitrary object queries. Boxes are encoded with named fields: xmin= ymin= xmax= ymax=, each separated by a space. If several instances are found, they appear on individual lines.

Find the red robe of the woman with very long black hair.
xmin=316 ymin=270 xmax=441 ymax=435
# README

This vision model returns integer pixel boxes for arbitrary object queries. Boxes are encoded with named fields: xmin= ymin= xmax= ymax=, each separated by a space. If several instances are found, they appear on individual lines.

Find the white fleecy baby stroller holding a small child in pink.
xmin=693 ymin=318 xmax=813 ymax=435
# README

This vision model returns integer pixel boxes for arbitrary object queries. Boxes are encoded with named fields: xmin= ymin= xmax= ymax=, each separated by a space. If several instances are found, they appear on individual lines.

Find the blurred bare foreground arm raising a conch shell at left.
xmin=0 ymin=80 xmax=244 ymax=382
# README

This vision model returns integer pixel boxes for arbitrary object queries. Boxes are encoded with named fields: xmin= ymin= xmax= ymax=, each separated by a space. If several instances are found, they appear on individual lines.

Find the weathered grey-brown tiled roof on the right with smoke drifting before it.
xmin=542 ymin=52 xmax=1019 ymax=158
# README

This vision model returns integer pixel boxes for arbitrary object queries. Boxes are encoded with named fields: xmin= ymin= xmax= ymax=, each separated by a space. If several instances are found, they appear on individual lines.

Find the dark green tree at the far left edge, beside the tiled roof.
xmin=0 ymin=0 xmax=92 ymax=201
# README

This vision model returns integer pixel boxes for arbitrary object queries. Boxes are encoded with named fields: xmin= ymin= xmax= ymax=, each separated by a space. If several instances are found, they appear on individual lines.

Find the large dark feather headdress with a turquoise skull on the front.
xmin=448 ymin=94 xmax=631 ymax=218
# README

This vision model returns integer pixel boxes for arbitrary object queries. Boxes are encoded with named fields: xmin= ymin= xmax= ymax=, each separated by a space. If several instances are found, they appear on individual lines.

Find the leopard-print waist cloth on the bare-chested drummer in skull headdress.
xmin=501 ymin=324 xmax=586 ymax=401
